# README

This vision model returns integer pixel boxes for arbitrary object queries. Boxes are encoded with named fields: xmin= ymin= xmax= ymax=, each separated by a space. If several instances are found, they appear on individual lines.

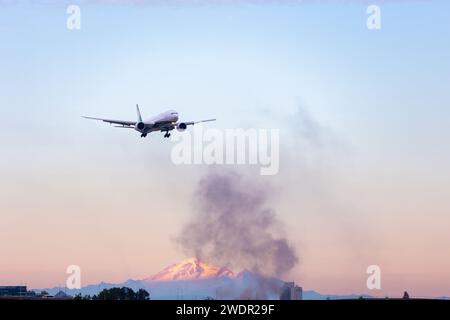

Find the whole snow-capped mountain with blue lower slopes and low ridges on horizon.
xmin=36 ymin=258 xmax=372 ymax=300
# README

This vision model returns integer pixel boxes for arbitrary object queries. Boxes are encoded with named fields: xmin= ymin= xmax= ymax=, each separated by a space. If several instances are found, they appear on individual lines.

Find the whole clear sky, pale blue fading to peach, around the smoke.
xmin=0 ymin=1 xmax=450 ymax=295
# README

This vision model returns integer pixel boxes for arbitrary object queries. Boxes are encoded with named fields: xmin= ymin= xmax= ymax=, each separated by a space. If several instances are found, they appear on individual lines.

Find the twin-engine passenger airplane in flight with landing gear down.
xmin=82 ymin=105 xmax=216 ymax=138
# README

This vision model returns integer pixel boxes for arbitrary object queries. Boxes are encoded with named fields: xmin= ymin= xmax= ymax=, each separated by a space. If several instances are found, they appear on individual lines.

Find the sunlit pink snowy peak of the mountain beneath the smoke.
xmin=145 ymin=257 xmax=235 ymax=281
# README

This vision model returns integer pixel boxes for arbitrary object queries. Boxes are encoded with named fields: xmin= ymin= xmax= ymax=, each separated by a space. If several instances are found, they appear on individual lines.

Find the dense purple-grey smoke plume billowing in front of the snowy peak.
xmin=177 ymin=173 xmax=298 ymax=276
